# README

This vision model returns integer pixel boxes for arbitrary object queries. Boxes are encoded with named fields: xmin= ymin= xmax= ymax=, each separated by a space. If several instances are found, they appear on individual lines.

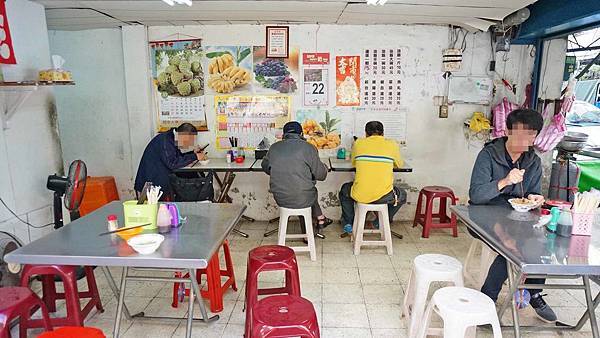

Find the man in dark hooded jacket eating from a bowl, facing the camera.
xmin=469 ymin=109 xmax=556 ymax=322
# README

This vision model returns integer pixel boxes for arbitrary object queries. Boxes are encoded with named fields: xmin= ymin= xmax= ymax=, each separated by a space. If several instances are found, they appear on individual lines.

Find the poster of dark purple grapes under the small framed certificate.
xmin=253 ymin=46 xmax=300 ymax=94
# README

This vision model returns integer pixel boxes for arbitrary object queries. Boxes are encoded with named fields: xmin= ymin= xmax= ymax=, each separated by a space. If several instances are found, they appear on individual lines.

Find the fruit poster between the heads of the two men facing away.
xmin=296 ymin=109 xmax=342 ymax=150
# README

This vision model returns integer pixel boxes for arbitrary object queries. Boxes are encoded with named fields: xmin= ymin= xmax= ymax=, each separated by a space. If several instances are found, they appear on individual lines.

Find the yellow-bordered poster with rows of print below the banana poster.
xmin=215 ymin=95 xmax=291 ymax=150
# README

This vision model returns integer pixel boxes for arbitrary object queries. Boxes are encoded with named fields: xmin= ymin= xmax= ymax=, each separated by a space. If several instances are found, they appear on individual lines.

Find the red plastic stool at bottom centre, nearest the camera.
xmin=247 ymin=295 xmax=320 ymax=338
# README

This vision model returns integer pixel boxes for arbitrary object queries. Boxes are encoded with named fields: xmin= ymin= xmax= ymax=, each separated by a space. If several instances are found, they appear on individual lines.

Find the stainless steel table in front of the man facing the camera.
xmin=450 ymin=205 xmax=600 ymax=338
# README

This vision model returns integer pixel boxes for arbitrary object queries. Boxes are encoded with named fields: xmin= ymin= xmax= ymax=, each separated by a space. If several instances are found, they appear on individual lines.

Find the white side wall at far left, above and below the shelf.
xmin=0 ymin=0 xmax=62 ymax=242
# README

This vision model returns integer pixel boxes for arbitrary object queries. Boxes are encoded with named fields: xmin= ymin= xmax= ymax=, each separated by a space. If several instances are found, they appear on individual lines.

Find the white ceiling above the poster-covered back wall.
xmin=34 ymin=0 xmax=536 ymax=30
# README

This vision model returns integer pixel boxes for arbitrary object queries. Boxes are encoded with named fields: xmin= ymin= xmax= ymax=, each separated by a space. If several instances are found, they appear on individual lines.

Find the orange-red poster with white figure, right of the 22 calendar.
xmin=335 ymin=56 xmax=360 ymax=106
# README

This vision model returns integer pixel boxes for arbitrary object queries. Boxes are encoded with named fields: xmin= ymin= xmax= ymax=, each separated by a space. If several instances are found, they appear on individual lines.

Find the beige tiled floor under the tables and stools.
xmin=13 ymin=222 xmax=600 ymax=338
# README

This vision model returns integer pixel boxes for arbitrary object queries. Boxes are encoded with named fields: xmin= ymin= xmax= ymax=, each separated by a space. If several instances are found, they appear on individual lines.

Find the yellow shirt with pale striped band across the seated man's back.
xmin=351 ymin=135 xmax=403 ymax=203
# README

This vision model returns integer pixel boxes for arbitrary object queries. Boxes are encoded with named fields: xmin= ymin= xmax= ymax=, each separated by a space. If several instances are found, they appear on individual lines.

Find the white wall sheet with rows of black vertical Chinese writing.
xmin=362 ymin=48 xmax=402 ymax=107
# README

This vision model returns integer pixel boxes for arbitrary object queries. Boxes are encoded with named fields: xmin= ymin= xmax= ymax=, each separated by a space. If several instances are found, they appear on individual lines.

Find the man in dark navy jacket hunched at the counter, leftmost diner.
xmin=134 ymin=123 xmax=206 ymax=197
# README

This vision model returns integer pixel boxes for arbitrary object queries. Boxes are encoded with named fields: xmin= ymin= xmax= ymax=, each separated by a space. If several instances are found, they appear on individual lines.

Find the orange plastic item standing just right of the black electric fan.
xmin=79 ymin=176 xmax=119 ymax=216
